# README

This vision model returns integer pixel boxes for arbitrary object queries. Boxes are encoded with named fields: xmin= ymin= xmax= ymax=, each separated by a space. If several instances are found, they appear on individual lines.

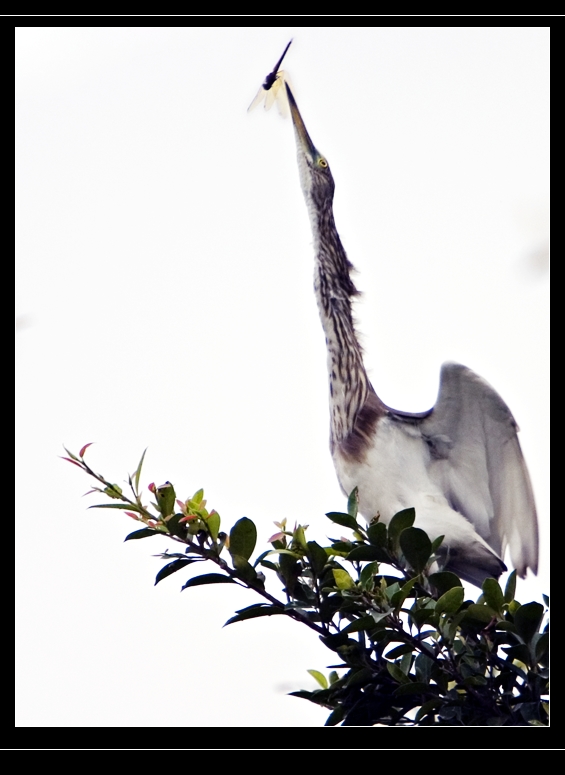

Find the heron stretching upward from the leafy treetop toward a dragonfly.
xmin=285 ymin=83 xmax=538 ymax=587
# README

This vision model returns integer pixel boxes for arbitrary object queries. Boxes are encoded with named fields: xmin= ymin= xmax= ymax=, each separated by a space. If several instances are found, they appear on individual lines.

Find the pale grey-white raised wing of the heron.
xmin=420 ymin=363 xmax=538 ymax=576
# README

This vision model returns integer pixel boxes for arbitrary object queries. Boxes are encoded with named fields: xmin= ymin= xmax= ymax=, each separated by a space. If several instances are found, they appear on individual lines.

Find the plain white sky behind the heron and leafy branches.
xmin=16 ymin=27 xmax=549 ymax=727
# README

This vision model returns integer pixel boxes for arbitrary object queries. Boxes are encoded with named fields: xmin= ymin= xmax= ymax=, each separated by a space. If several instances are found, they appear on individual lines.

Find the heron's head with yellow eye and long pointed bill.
xmin=285 ymin=83 xmax=335 ymax=212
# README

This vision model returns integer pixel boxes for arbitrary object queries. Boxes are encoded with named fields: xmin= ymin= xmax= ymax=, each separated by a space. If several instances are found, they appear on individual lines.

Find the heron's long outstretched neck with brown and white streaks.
xmin=308 ymin=207 xmax=372 ymax=447
